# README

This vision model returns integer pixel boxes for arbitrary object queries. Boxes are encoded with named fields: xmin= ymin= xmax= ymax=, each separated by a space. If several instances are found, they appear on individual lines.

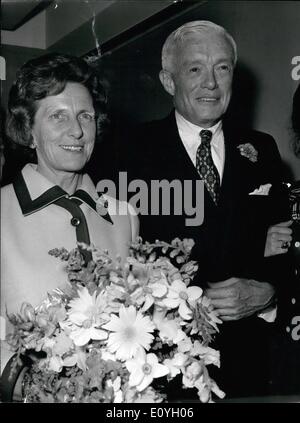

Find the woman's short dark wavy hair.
xmin=6 ymin=53 xmax=106 ymax=147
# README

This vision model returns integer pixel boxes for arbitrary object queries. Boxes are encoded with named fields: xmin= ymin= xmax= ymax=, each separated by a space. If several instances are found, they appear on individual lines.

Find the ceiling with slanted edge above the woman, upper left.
xmin=1 ymin=0 xmax=200 ymax=56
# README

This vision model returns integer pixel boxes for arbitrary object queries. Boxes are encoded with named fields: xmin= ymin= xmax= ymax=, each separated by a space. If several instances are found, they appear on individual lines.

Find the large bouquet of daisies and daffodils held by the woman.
xmin=7 ymin=238 xmax=224 ymax=403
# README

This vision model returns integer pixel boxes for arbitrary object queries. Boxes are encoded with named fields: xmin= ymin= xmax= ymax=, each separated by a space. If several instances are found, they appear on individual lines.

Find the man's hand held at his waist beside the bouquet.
xmin=205 ymin=278 xmax=275 ymax=321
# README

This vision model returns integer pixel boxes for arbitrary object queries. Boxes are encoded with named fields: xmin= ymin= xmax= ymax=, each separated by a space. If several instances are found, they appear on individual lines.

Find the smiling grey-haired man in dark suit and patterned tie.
xmin=119 ymin=21 xmax=292 ymax=396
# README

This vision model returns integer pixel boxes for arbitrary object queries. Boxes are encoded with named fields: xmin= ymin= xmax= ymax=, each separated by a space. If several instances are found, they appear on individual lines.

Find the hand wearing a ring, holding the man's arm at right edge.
xmin=265 ymin=220 xmax=293 ymax=257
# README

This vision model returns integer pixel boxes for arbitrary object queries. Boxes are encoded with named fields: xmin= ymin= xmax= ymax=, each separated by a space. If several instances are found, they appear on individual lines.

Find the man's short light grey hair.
xmin=162 ymin=21 xmax=237 ymax=71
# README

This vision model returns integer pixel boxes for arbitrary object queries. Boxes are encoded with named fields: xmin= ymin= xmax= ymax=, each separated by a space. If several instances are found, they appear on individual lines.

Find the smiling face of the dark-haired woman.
xmin=32 ymin=82 xmax=96 ymax=177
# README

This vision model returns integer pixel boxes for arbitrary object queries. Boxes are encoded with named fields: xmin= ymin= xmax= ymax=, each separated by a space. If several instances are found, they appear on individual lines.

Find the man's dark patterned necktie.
xmin=196 ymin=129 xmax=220 ymax=205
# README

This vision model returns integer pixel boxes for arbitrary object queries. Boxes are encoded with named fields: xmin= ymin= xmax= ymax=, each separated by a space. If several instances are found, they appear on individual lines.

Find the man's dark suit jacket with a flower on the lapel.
xmin=117 ymin=112 xmax=292 ymax=396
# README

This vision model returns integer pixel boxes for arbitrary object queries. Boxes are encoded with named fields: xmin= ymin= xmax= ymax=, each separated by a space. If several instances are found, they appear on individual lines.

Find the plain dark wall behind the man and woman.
xmin=1 ymin=0 xmax=300 ymax=179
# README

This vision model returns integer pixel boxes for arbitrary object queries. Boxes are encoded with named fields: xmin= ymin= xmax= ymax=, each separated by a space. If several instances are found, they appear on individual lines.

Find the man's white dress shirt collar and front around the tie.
xmin=175 ymin=111 xmax=225 ymax=183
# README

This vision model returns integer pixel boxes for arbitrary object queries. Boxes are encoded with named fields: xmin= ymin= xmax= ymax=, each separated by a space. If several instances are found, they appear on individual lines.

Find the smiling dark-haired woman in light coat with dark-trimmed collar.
xmin=0 ymin=54 xmax=138 ymax=398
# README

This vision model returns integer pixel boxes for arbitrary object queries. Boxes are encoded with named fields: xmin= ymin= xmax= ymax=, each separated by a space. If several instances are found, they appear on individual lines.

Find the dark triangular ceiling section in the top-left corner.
xmin=1 ymin=0 xmax=53 ymax=31
